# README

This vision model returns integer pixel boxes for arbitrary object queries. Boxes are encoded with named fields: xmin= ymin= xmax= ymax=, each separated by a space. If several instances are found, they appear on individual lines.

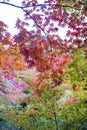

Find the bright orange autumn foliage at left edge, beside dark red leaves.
xmin=0 ymin=45 xmax=26 ymax=71
